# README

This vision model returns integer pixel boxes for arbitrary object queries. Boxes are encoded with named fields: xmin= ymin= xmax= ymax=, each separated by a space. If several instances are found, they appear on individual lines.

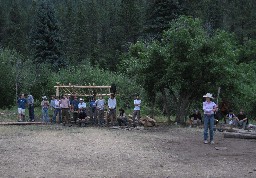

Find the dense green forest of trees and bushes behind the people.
xmin=0 ymin=0 xmax=256 ymax=122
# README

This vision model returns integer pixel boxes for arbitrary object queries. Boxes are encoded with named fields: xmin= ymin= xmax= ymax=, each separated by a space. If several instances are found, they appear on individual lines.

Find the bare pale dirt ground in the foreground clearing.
xmin=0 ymin=125 xmax=256 ymax=178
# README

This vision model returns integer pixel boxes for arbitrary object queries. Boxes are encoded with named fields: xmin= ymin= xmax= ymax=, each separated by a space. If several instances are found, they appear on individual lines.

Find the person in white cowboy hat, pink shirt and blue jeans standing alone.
xmin=203 ymin=93 xmax=218 ymax=144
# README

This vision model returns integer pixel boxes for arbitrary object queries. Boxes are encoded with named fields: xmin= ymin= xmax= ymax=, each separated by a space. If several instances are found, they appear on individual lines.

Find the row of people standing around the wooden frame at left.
xmin=17 ymin=93 xmax=141 ymax=127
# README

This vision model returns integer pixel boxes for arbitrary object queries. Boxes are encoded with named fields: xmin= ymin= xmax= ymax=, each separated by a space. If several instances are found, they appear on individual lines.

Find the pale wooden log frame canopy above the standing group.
xmin=54 ymin=82 xmax=111 ymax=96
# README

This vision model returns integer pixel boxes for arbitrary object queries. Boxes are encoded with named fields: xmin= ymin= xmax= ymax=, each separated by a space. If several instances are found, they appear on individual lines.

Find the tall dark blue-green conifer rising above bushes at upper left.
xmin=31 ymin=0 xmax=66 ymax=68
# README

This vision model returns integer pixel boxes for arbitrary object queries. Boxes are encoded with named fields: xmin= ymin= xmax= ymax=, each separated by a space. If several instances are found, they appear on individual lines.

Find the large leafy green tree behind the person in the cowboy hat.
xmin=122 ymin=16 xmax=246 ymax=121
